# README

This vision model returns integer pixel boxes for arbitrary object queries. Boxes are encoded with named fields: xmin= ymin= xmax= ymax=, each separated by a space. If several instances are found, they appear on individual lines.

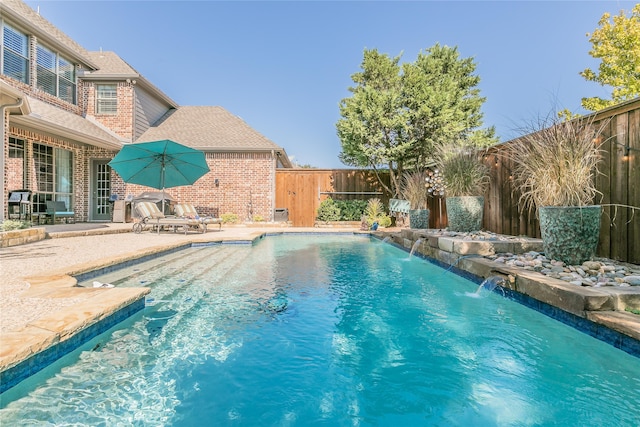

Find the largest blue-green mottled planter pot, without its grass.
xmin=538 ymin=205 xmax=602 ymax=265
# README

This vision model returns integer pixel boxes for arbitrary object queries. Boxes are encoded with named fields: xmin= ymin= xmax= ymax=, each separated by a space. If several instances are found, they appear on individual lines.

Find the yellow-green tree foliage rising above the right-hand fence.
xmin=580 ymin=3 xmax=640 ymax=111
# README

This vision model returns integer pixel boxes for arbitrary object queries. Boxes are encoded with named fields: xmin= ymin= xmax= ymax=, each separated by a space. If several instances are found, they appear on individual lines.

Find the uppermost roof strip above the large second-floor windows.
xmin=0 ymin=0 xmax=96 ymax=68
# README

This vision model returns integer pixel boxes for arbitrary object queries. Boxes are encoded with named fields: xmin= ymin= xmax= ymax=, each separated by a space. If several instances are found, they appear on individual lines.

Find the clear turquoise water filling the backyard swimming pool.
xmin=0 ymin=235 xmax=640 ymax=426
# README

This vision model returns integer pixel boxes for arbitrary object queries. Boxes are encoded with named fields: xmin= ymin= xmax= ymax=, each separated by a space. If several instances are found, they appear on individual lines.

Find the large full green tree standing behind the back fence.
xmin=336 ymin=44 xmax=496 ymax=197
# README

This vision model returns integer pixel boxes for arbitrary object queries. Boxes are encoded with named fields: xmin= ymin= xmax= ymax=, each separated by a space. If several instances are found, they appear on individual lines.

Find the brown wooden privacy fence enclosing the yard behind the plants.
xmin=276 ymin=98 xmax=640 ymax=264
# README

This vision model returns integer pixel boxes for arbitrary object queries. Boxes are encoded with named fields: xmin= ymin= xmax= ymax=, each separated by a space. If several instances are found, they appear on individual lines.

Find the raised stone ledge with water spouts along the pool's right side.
xmin=374 ymin=229 xmax=640 ymax=356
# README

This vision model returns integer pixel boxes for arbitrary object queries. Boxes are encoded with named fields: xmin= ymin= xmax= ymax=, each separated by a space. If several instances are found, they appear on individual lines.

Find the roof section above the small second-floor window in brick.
xmin=78 ymin=51 xmax=178 ymax=108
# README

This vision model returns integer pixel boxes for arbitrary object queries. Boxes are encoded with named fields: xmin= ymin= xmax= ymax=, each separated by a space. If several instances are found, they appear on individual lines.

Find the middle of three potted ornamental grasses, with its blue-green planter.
xmin=436 ymin=144 xmax=489 ymax=232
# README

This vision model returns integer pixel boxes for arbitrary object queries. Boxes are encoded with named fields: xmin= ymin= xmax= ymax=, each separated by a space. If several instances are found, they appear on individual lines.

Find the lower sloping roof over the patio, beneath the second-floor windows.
xmin=11 ymin=96 xmax=125 ymax=150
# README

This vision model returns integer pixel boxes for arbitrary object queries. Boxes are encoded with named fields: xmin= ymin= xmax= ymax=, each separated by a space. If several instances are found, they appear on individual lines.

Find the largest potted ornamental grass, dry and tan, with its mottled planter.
xmin=508 ymin=118 xmax=605 ymax=265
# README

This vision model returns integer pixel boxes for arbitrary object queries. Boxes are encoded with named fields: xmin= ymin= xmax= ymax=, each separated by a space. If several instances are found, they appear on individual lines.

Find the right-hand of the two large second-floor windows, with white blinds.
xmin=36 ymin=45 xmax=76 ymax=104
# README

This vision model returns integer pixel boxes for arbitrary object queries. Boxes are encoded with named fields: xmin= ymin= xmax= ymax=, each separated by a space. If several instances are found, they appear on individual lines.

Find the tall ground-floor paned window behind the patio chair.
xmin=33 ymin=144 xmax=73 ymax=212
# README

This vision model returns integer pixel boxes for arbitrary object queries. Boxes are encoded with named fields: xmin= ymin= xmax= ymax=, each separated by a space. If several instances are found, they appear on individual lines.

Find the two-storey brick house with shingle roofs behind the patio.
xmin=0 ymin=0 xmax=291 ymax=221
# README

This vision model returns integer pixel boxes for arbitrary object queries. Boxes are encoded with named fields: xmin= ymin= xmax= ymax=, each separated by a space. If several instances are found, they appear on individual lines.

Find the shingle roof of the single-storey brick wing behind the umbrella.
xmin=136 ymin=106 xmax=283 ymax=151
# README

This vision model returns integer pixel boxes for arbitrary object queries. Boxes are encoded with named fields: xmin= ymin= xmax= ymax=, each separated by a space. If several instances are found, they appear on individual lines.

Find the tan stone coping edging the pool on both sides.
xmin=0 ymin=229 xmax=640 ymax=394
